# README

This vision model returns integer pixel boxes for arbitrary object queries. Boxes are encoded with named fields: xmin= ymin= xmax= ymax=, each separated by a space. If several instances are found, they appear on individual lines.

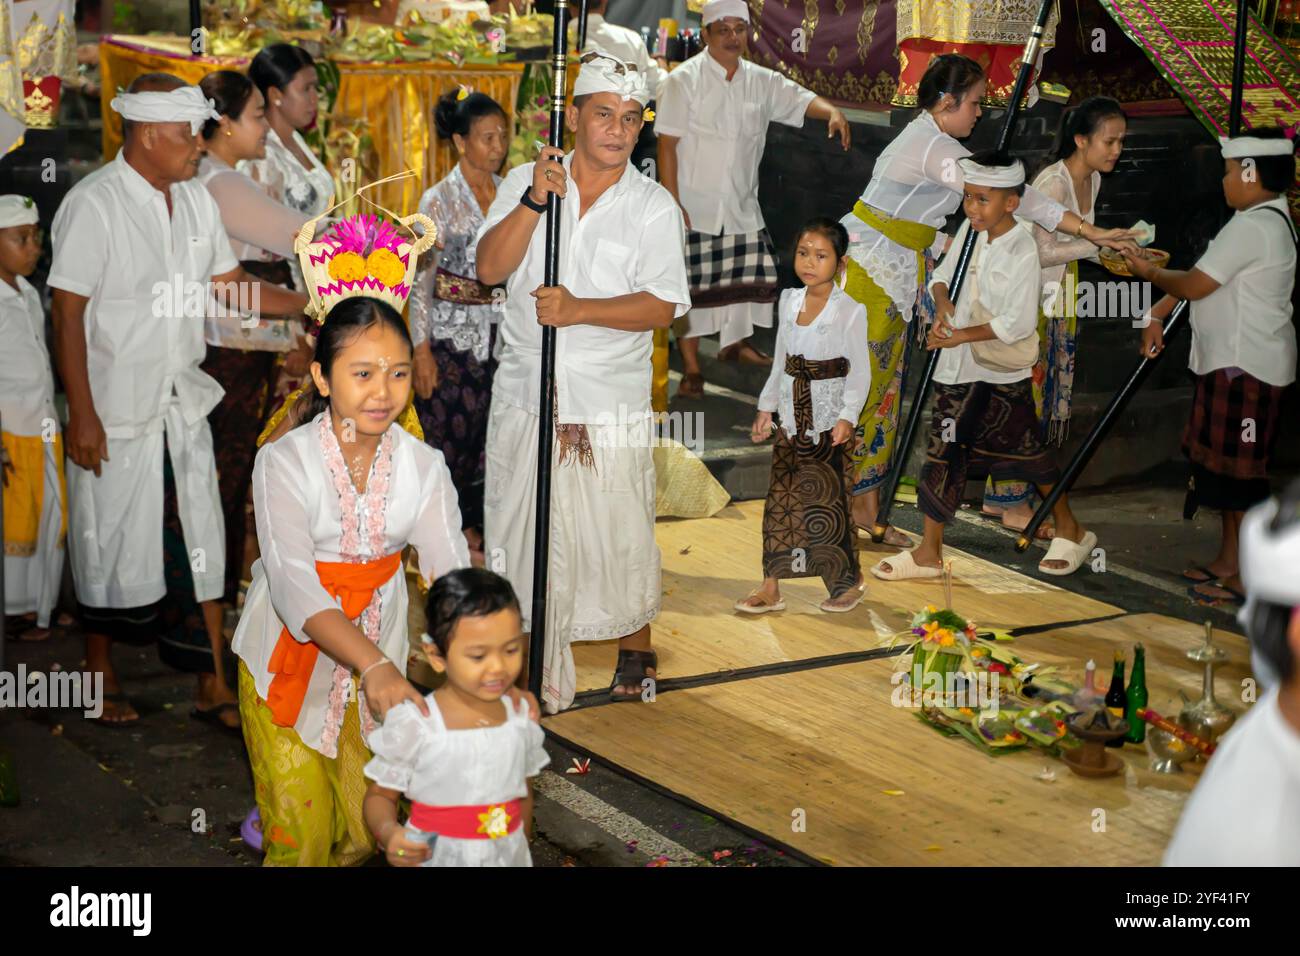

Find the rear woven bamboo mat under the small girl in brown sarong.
xmin=573 ymin=501 xmax=1122 ymax=691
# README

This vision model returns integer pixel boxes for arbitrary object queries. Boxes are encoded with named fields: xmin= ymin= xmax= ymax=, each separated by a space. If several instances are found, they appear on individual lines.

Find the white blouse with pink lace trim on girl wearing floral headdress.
xmin=233 ymin=412 xmax=469 ymax=757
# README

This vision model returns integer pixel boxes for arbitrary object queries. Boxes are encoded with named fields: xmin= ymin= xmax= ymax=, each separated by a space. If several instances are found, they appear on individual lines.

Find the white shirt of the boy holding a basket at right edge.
xmin=1191 ymin=196 xmax=1296 ymax=385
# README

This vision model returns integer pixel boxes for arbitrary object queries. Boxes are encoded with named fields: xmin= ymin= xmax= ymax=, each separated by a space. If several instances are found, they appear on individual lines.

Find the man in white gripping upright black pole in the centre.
xmin=477 ymin=52 xmax=690 ymax=711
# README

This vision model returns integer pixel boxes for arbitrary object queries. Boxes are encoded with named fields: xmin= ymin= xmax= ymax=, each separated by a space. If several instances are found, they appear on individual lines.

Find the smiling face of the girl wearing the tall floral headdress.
xmin=312 ymin=323 xmax=411 ymax=436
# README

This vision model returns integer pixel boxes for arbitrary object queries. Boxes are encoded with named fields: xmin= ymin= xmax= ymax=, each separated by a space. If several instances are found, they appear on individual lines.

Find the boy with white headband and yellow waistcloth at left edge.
xmin=0 ymin=195 xmax=66 ymax=641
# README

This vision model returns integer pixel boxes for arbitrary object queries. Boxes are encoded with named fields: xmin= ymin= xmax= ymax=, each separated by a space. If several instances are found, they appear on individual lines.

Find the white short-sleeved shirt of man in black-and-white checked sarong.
xmin=654 ymin=49 xmax=816 ymax=235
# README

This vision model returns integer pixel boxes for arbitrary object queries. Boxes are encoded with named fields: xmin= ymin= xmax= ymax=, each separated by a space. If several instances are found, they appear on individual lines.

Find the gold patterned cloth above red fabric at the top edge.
xmin=897 ymin=0 xmax=1061 ymax=49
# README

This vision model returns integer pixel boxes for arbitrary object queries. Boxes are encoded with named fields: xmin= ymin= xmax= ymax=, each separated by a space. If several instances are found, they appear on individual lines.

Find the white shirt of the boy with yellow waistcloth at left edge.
xmin=0 ymin=276 xmax=59 ymax=437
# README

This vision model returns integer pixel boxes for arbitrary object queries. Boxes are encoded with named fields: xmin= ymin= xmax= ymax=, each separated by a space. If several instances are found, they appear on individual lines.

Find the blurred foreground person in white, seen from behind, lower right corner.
xmin=1165 ymin=483 xmax=1300 ymax=866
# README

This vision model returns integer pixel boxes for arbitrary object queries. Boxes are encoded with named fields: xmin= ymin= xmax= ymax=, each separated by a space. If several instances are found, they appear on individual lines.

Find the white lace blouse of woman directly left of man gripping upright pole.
xmin=411 ymin=163 xmax=501 ymax=362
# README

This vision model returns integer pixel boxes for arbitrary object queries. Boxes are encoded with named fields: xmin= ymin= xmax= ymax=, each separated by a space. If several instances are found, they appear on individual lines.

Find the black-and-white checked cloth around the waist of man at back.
xmin=686 ymin=229 xmax=780 ymax=308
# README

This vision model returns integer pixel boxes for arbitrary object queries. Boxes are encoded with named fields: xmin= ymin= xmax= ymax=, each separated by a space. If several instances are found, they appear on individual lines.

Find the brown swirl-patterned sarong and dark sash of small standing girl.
xmin=763 ymin=355 xmax=859 ymax=597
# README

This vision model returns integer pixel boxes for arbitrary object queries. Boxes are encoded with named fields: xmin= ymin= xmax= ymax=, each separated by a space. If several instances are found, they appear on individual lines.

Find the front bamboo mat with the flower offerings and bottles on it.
xmin=543 ymin=615 xmax=1247 ymax=866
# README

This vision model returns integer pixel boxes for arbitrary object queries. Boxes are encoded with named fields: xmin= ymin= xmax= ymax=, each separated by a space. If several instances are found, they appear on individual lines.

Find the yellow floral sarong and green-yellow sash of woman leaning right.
xmin=844 ymin=199 xmax=939 ymax=494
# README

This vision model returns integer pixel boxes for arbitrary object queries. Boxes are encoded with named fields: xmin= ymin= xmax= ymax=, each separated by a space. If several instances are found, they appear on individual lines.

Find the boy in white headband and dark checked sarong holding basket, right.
xmin=1125 ymin=130 xmax=1296 ymax=604
